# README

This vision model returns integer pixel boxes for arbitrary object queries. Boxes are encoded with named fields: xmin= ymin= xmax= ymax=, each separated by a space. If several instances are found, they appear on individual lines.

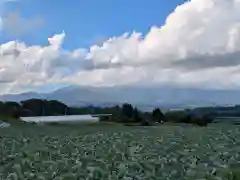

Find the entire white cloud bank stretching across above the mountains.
xmin=0 ymin=0 xmax=240 ymax=91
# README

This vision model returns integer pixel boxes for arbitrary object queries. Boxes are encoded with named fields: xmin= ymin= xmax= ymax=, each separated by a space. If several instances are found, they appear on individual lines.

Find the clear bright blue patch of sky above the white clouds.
xmin=0 ymin=0 xmax=184 ymax=49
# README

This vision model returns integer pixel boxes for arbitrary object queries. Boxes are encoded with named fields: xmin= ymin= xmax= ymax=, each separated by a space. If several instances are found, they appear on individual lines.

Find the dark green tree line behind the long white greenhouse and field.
xmin=0 ymin=99 xmax=213 ymax=126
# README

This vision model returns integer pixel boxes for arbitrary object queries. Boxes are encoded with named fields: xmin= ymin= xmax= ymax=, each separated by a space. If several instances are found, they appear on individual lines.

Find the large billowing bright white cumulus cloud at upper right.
xmin=86 ymin=0 xmax=240 ymax=67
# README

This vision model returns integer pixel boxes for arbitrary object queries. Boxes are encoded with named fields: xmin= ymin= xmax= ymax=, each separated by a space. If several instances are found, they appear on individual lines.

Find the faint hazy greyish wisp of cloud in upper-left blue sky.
xmin=2 ymin=12 xmax=44 ymax=37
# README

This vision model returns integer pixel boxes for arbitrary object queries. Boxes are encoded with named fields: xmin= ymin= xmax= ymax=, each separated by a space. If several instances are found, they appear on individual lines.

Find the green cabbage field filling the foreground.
xmin=0 ymin=125 xmax=240 ymax=180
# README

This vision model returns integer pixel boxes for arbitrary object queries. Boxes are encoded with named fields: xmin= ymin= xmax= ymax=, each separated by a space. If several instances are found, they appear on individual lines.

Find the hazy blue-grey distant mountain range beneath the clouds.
xmin=0 ymin=86 xmax=240 ymax=110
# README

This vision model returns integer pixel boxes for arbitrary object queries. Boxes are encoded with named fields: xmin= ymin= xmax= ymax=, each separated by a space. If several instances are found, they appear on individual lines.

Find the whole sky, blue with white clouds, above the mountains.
xmin=0 ymin=0 xmax=240 ymax=94
